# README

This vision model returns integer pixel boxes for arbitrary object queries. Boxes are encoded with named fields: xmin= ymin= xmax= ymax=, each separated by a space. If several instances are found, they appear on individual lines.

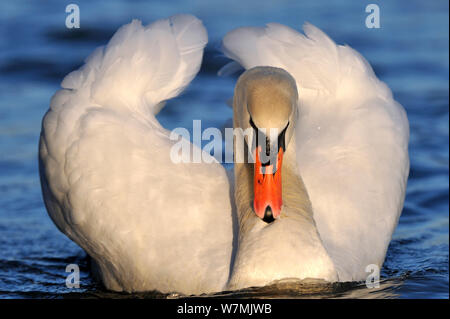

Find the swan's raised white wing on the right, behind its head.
xmin=223 ymin=23 xmax=409 ymax=281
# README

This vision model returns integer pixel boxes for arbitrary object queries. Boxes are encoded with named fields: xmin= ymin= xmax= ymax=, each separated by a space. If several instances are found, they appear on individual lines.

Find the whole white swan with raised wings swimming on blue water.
xmin=39 ymin=15 xmax=409 ymax=294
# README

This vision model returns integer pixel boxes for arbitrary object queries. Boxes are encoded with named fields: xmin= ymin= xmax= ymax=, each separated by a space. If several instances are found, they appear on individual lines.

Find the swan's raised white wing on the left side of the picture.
xmin=39 ymin=15 xmax=232 ymax=293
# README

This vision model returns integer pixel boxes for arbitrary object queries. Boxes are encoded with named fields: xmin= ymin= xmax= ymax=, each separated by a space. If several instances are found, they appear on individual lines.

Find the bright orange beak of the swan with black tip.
xmin=253 ymin=146 xmax=283 ymax=223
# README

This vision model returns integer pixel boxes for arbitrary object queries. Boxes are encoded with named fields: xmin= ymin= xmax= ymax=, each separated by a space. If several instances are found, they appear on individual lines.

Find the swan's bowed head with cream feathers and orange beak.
xmin=235 ymin=67 xmax=298 ymax=223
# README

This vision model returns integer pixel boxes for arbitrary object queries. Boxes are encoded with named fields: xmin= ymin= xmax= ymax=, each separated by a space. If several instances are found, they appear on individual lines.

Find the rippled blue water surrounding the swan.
xmin=0 ymin=0 xmax=449 ymax=298
